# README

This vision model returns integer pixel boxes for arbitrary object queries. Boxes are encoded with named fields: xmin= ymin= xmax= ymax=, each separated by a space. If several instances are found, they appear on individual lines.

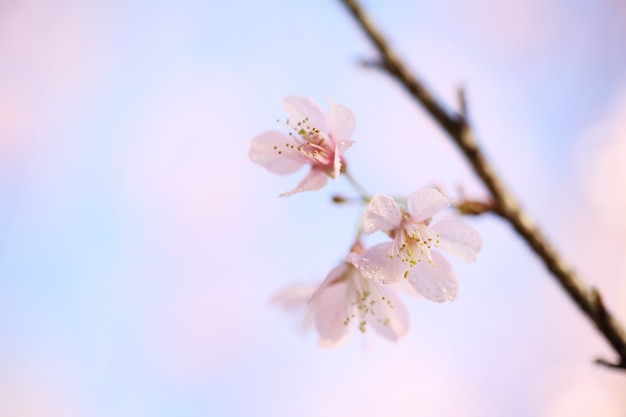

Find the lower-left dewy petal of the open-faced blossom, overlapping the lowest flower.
xmin=356 ymin=242 xmax=407 ymax=284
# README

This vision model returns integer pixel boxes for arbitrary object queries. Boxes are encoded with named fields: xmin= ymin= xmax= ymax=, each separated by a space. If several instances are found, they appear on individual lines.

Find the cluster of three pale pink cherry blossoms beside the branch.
xmin=249 ymin=97 xmax=482 ymax=346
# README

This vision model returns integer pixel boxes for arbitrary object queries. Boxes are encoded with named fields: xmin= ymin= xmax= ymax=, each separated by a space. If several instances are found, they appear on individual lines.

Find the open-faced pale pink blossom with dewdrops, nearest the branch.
xmin=356 ymin=188 xmax=482 ymax=302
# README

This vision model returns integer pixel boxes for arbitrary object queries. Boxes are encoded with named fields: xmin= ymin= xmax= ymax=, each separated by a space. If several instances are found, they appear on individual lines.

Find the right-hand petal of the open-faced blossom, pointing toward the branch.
xmin=430 ymin=217 xmax=483 ymax=262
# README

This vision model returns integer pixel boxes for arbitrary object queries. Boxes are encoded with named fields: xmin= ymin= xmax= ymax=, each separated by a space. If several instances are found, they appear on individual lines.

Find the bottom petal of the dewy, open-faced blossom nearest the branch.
xmin=409 ymin=251 xmax=459 ymax=303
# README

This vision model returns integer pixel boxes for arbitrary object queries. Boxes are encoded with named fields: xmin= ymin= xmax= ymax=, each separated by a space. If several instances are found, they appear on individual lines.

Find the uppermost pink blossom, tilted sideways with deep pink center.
xmin=248 ymin=97 xmax=354 ymax=197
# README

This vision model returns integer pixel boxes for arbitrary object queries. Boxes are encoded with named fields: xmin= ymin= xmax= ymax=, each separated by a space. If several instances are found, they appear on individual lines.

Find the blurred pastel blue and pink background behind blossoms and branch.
xmin=0 ymin=0 xmax=626 ymax=417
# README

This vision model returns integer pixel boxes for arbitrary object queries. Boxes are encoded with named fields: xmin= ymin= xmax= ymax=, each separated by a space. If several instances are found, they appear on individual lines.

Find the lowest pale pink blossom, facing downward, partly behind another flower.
xmin=273 ymin=249 xmax=409 ymax=347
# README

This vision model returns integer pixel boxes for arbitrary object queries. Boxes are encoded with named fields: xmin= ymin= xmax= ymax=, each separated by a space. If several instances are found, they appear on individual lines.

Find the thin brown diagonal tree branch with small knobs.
xmin=340 ymin=0 xmax=626 ymax=369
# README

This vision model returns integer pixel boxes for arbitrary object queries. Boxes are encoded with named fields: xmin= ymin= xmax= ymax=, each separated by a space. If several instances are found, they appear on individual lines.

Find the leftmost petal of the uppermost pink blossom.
xmin=248 ymin=131 xmax=306 ymax=175
